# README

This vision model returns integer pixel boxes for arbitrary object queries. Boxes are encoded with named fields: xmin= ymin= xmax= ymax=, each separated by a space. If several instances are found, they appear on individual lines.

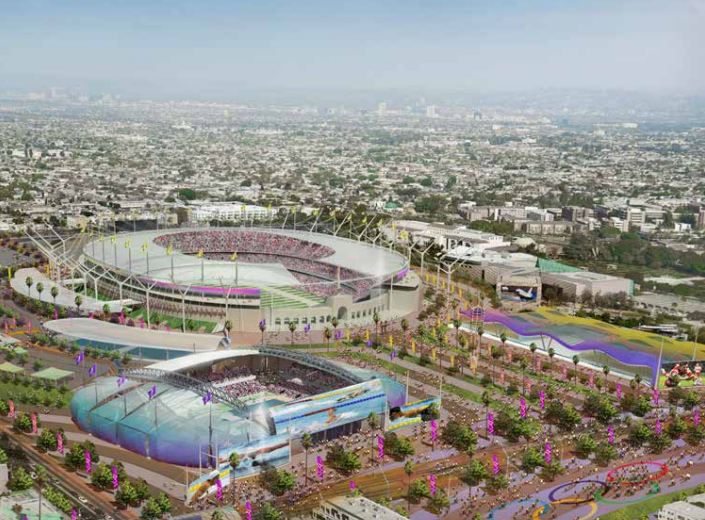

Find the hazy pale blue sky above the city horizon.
xmin=0 ymin=0 xmax=705 ymax=96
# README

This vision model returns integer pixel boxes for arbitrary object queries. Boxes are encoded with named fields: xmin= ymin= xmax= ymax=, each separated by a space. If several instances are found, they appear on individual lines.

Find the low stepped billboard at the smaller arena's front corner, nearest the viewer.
xmin=186 ymin=435 xmax=291 ymax=503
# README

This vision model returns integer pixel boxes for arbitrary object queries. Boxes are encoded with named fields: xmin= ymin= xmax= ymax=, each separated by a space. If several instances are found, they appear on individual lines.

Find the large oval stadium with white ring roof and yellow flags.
xmin=72 ymin=228 xmax=421 ymax=332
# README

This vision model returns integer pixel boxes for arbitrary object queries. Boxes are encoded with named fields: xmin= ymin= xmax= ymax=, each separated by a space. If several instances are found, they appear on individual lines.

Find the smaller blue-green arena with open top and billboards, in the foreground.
xmin=71 ymin=347 xmax=417 ymax=500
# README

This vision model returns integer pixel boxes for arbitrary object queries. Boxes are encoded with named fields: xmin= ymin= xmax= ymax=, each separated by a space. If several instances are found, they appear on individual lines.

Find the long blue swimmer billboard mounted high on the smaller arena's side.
xmin=269 ymin=379 xmax=387 ymax=435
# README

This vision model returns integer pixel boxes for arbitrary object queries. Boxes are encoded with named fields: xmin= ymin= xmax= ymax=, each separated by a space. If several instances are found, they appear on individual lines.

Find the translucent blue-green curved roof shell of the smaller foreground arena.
xmin=71 ymin=347 xmax=405 ymax=466
